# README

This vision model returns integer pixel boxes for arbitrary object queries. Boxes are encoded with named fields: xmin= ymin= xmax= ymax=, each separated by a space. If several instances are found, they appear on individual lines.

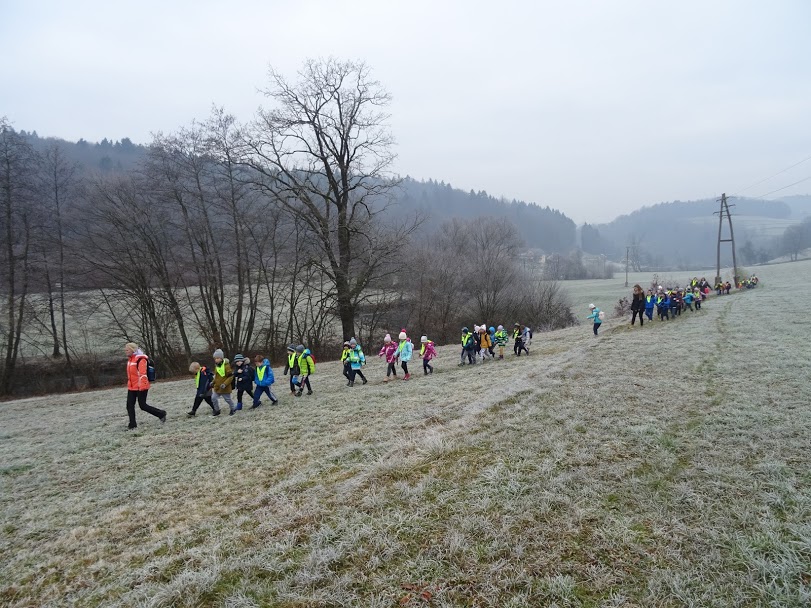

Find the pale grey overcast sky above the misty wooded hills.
xmin=0 ymin=0 xmax=811 ymax=223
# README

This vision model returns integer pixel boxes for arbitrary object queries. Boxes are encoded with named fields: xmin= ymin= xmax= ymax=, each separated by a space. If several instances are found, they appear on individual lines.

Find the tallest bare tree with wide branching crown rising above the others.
xmin=243 ymin=58 xmax=408 ymax=337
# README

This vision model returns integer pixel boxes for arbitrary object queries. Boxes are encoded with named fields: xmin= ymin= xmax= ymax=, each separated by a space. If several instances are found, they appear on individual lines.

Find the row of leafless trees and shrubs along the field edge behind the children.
xmin=0 ymin=59 xmax=566 ymax=394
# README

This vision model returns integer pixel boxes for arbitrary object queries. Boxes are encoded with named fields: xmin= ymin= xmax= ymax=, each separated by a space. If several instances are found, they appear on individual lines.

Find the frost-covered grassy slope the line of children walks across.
xmin=0 ymin=262 xmax=811 ymax=607
